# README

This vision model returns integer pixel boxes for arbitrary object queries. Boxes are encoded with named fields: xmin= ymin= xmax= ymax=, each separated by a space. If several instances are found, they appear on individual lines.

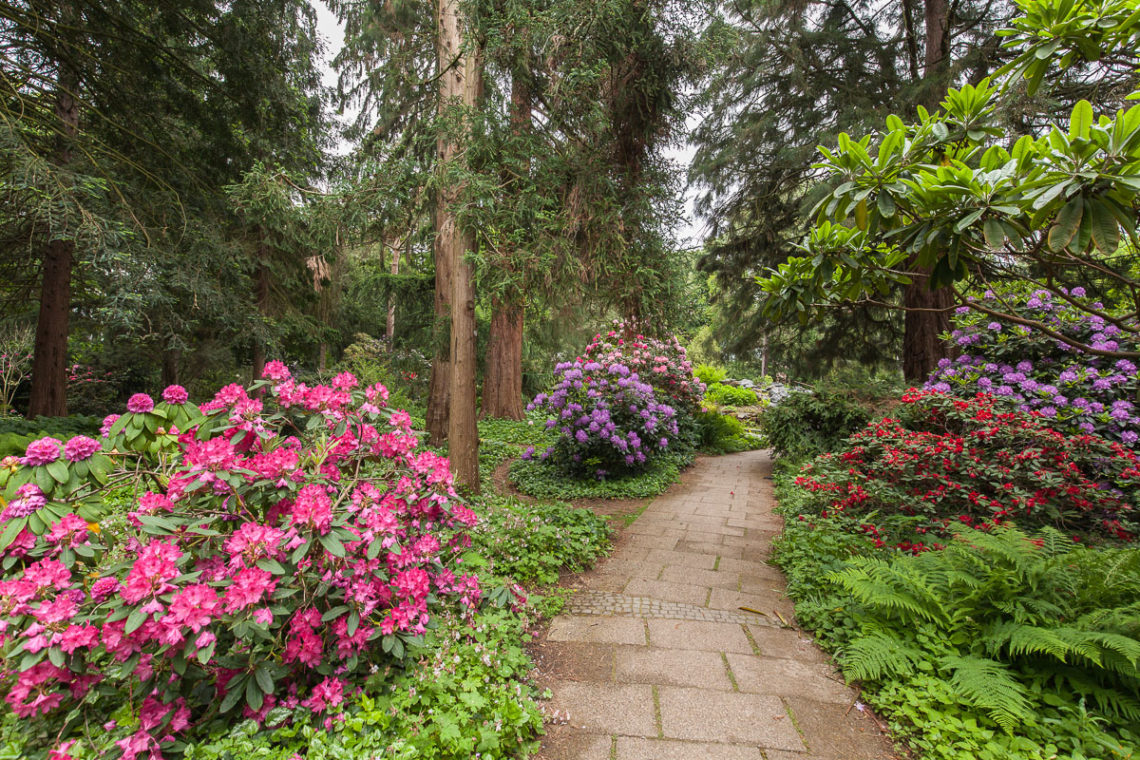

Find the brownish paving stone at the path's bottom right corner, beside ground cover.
xmin=780 ymin=697 xmax=895 ymax=760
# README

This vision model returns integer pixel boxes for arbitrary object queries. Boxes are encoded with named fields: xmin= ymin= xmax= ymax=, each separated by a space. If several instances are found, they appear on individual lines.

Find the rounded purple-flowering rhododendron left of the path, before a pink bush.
xmin=523 ymin=359 xmax=678 ymax=476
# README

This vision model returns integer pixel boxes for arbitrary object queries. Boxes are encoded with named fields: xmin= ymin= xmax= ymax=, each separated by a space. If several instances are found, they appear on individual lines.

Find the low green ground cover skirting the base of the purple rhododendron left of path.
xmin=511 ymin=453 xmax=693 ymax=499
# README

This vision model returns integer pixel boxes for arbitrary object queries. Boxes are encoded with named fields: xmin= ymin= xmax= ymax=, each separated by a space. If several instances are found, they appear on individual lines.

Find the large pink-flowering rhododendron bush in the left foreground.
xmin=0 ymin=362 xmax=480 ymax=760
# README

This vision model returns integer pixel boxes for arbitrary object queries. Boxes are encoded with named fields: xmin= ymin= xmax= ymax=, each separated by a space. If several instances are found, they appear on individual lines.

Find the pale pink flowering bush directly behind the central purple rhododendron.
xmin=583 ymin=320 xmax=705 ymax=416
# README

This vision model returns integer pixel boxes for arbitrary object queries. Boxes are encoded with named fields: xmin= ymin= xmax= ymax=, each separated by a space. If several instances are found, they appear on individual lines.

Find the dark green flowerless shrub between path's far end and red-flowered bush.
xmin=760 ymin=391 xmax=871 ymax=457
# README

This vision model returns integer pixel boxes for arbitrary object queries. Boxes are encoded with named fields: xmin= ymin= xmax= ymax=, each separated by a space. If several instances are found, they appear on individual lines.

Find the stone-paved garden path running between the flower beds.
xmin=535 ymin=451 xmax=896 ymax=760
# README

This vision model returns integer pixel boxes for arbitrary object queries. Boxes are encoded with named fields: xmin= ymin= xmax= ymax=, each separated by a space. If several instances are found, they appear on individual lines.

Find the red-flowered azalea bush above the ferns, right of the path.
xmin=796 ymin=389 xmax=1140 ymax=553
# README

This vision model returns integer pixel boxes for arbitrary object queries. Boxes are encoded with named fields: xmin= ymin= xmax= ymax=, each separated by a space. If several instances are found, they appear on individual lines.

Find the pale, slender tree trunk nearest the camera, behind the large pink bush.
xmin=433 ymin=0 xmax=482 ymax=491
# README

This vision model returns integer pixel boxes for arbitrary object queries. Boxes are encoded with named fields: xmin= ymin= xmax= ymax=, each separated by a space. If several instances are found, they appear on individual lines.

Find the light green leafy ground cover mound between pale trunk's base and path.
xmin=469 ymin=496 xmax=610 ymax=586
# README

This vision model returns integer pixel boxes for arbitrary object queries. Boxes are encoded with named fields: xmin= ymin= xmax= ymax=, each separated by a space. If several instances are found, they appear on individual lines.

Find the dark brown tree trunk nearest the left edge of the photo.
xmin=27 ymin=52 xmax=79 ymax=417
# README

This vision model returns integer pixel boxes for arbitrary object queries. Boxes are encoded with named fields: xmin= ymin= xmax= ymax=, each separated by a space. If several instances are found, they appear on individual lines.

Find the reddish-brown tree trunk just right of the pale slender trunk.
xmin=483 ymin=72 xmax=531 ymax=419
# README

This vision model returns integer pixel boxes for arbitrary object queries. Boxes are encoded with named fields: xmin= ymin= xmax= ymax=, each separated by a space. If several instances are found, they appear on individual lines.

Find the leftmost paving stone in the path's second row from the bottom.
xmin=545 ymin=681 xmax=661 ymax=738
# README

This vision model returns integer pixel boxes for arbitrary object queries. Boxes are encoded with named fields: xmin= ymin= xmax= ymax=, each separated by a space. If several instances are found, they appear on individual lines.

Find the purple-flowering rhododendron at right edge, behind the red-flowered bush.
xmin=927 ymin=287 xmax=1140 ymax=448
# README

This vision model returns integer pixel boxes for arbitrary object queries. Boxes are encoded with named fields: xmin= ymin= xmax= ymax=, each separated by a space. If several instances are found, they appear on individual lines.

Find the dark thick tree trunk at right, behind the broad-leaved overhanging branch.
xmin=903 ymin=0 xmax=954 ymax=384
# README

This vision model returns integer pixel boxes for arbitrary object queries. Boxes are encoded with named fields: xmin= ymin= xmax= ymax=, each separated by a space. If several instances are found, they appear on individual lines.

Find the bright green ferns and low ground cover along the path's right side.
xmin=776 ymin=467 xmax=1140 ymax=760
